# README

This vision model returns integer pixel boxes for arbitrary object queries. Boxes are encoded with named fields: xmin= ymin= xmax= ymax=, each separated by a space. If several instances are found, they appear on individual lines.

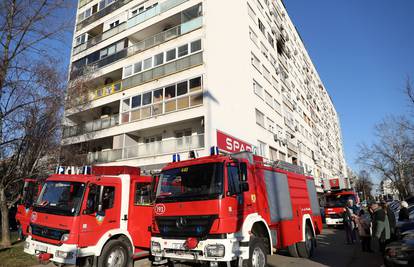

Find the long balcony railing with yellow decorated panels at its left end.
xmin=66 ymin=52 xmax=203 ymax=108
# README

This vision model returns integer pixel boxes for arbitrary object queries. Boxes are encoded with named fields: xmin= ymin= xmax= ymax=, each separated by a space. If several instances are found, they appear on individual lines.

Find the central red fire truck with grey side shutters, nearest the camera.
xmin=151 ymin=152 xmax=322 ymax=266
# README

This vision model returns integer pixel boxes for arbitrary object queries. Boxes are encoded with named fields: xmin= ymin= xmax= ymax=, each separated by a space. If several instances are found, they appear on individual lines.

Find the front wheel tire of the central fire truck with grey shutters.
xmin=243 ymin=236 xmax=268 ymax=267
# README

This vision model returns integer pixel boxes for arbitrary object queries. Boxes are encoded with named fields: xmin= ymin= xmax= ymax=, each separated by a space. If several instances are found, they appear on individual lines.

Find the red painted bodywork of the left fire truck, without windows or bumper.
xmin=30 ymin=166 xmax=155 ymax=260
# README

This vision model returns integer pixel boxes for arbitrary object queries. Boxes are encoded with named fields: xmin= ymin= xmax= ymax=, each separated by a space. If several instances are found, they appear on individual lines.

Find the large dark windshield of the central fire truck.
xmin=157 ymin=163 xmax=223 ymax=202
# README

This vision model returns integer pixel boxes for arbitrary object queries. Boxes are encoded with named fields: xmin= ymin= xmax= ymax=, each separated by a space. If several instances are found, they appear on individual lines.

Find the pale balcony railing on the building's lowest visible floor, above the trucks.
xmin=88 ymin=134 xmax=204 ymax=164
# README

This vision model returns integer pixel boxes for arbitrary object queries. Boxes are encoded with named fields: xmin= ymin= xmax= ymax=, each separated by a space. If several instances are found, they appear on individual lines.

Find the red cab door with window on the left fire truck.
xmin=79 ymin=181 xmax=122 ymax=247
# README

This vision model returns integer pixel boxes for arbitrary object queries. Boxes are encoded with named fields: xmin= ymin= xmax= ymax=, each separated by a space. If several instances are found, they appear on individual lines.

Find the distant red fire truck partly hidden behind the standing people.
xmin=325 ymin=189 xmax=358 ymax=226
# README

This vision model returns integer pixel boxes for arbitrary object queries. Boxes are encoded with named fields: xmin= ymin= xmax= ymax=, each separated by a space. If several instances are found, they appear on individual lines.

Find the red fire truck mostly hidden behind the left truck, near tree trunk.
xmin=16 ymin=178 xmax=41 ymax=238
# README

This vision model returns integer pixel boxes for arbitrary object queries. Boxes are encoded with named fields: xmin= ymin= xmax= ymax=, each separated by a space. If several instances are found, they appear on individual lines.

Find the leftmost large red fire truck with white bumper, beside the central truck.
xmin=24 ymin=166 xmax=155 ymax=267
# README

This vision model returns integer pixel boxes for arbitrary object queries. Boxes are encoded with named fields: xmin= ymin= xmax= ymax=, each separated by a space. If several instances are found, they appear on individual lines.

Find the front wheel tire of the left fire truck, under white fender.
xmin=98 ymin=239 xmax=132 ymax=267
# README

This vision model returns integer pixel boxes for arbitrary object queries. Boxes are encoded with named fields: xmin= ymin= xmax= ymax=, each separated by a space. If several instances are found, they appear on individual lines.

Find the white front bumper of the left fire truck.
xmin=24 ymin=236 xmax=78 ymax=265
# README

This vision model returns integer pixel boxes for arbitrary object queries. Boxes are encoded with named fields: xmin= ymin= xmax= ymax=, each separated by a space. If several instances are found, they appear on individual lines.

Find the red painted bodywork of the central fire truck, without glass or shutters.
xmin=153 ymin=155 xmax=322 ymax=251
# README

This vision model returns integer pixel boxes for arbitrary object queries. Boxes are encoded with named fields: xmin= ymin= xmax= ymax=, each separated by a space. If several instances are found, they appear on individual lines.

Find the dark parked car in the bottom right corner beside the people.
xmin=384 ymin=230 xmax=414 ymax=267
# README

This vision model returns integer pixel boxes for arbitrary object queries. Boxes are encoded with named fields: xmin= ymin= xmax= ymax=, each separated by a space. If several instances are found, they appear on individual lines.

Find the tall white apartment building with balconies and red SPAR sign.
xmin=62 ymin=0 xmax=346 ymax=191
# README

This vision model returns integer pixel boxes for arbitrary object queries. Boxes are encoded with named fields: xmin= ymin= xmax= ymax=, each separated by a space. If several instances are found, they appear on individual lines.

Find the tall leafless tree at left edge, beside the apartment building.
xmin=0 ymin=0 xmax=72 ymax=247
